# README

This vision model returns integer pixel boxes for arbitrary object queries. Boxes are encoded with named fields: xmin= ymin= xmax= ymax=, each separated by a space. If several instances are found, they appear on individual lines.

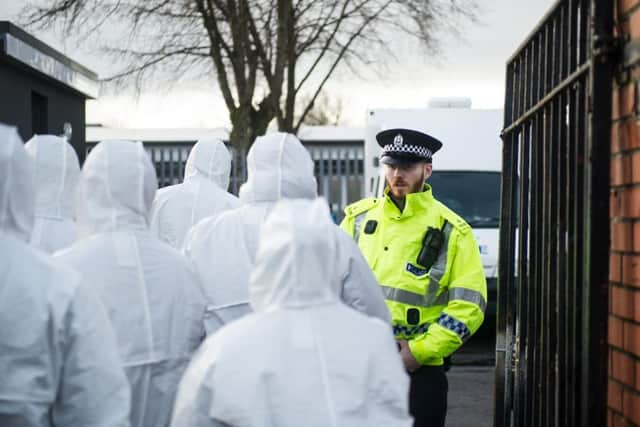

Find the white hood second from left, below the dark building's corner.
xmin=25 ymin=135 xmax=80 ymax=219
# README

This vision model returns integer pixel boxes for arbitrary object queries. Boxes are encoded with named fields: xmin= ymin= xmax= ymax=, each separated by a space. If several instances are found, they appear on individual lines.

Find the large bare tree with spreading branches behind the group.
xmin=22 ymin=0 xmax=477 ymax=147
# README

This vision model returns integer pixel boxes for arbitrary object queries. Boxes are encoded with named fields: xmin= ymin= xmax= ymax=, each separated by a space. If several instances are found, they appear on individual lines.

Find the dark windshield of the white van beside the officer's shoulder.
xmin=427 ymin=171 xmax=500 ymax=228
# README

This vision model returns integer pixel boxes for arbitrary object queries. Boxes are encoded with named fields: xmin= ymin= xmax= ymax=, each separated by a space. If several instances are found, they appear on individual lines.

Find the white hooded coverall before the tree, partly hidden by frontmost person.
xmin=184 ymin=133 xmax=390 ymax=335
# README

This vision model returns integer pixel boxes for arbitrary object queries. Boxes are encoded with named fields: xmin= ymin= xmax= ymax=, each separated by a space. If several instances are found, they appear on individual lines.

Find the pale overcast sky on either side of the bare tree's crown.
xmin=0 ymin=0 xmax=555 ymax=128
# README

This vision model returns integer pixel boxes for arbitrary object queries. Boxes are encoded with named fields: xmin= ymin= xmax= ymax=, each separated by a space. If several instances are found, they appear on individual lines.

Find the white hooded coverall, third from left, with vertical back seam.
xmin=56 ymin=141 xmax=204 ymax=427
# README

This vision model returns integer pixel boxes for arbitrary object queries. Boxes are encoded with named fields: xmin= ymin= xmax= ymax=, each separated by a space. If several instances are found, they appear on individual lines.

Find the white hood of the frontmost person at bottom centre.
xmin=249 ymin=199 xmax=339 ymax=312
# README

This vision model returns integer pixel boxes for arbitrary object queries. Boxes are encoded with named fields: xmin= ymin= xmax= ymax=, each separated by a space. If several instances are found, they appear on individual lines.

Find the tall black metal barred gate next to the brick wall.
xmin=494 ymin=0 xmax=614 ymax=426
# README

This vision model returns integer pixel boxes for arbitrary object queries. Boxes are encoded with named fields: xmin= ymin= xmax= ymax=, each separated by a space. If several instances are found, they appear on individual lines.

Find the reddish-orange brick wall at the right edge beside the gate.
xmin=607 ymin=0 xmax=640 ymax=427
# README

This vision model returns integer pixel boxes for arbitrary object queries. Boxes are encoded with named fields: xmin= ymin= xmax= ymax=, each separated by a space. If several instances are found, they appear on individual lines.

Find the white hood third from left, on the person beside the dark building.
xmin=76 ymin=141 xmax=158 ymax=236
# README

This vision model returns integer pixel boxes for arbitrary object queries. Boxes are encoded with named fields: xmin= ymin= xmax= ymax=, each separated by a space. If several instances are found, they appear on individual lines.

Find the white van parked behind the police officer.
xmin=364 ymin=102 xmax=503 ymax=317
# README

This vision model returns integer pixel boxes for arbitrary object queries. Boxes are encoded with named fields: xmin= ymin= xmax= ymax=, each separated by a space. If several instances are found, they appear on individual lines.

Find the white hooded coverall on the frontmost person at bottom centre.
xmin=171 ymin=199 xmax=412 ymax=427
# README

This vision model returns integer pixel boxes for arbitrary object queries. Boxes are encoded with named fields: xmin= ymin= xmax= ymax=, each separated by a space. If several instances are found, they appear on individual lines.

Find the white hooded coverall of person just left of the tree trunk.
xmin=151 ymin=139 xmax=240 ymax=249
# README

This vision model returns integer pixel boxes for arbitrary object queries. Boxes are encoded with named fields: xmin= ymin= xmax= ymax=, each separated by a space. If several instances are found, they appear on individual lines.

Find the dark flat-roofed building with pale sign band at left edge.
xmin=0 ymin=21 xmax=98 ymax=161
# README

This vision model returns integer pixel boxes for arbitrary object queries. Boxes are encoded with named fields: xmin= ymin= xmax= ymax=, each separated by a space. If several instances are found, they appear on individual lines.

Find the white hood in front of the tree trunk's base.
xmin=240 ymin=132 xmax=317 ymax=203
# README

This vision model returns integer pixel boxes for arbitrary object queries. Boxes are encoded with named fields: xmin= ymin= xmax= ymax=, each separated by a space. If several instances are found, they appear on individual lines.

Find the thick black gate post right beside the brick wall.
xmin=582 ymin=0 xmax=614 ymax=425
